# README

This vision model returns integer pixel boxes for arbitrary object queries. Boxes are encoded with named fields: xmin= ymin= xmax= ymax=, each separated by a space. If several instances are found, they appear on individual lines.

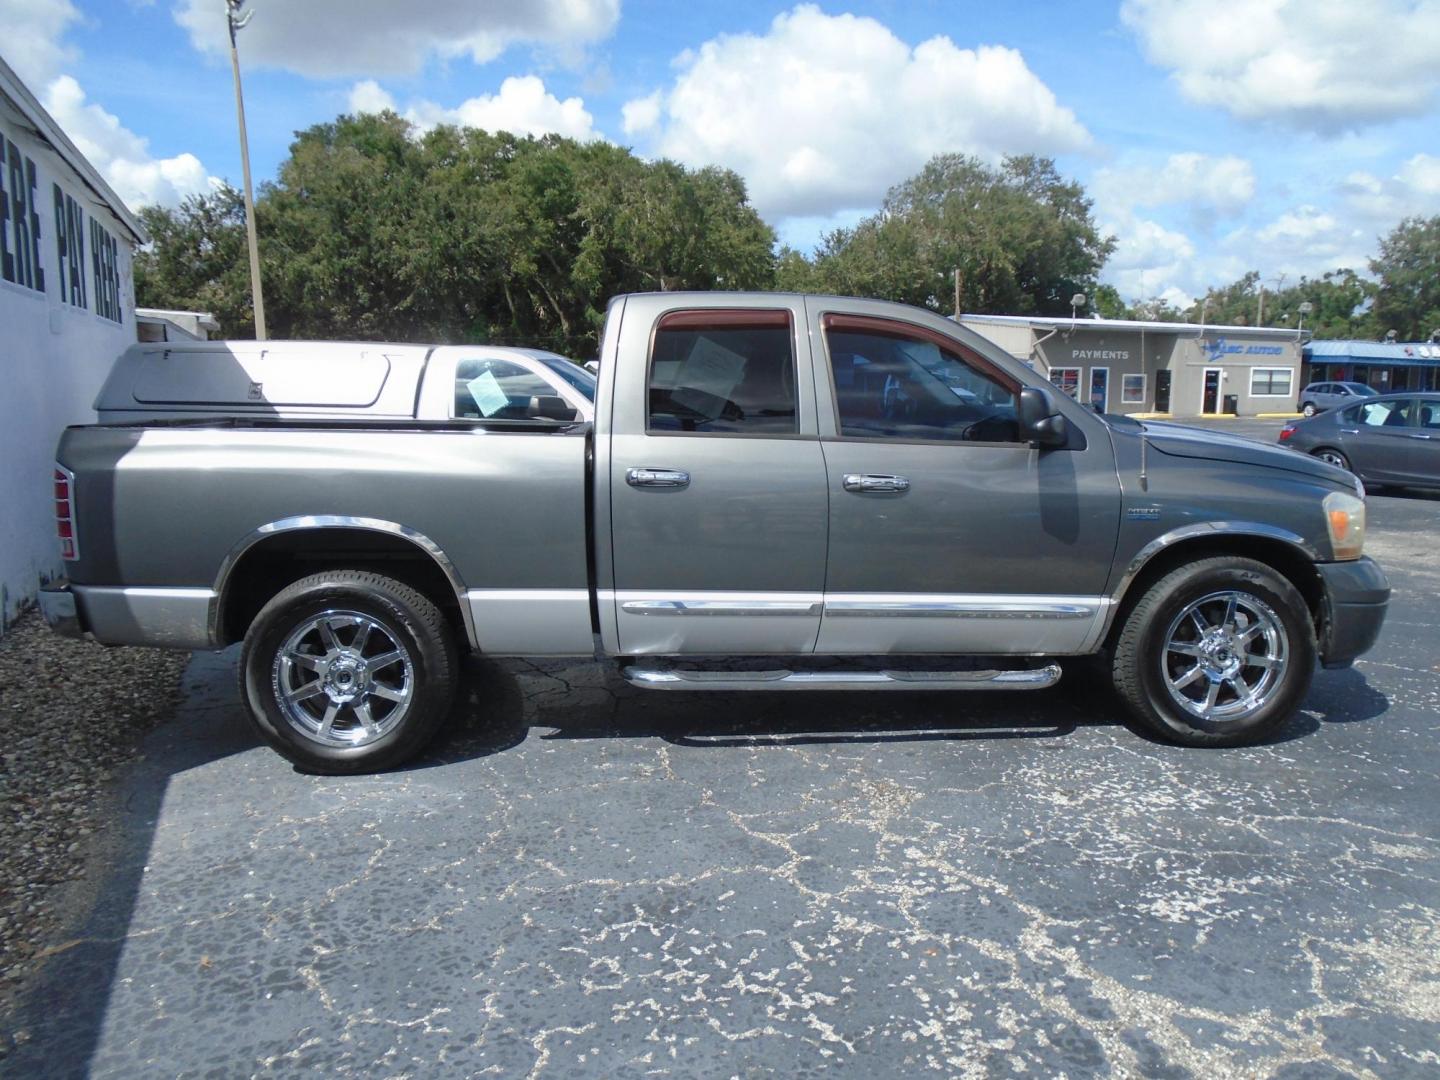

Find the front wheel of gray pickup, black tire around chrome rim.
xmin=1110 ymin=556 xmax=1316 ymax=746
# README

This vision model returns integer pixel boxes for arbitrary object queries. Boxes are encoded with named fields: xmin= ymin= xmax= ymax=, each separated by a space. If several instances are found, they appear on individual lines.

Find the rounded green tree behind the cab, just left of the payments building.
xmin=814 ymin=154 xmax=1115 ymax=315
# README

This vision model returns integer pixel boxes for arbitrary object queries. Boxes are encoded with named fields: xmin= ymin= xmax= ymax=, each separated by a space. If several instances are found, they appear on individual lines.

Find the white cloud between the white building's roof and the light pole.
xmin=43 ymin=75 xmax=217 ymax=207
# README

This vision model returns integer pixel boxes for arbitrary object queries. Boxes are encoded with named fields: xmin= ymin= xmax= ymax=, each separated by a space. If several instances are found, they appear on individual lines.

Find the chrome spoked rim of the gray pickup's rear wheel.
xmin=272 ymin=611 xmax=415 ymax=749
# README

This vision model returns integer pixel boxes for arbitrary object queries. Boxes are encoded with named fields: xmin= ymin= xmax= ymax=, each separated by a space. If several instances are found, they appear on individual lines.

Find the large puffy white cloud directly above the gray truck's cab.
xmin=625 ymin=4 xmax=1090 ymax=216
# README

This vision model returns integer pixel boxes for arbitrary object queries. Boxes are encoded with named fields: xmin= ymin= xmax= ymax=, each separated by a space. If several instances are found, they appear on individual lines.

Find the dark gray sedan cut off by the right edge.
xmin=1280 ymin=392 xmax=1440 ymax=488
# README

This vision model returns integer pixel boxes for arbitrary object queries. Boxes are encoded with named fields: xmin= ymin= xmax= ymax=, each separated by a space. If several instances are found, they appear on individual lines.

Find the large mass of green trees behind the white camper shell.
xmin=137 ymin=114 xmax=775 ymax=356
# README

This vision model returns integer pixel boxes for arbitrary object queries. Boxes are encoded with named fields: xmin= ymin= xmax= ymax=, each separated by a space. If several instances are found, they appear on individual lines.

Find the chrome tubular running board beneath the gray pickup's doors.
xmin=625 ymin=664 xmax=1060 ymax=690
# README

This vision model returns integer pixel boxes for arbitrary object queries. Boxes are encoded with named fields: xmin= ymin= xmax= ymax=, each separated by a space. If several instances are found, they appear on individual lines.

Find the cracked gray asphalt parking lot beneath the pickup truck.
xmin=4 ymin=420 xmax=1440 ymax=1077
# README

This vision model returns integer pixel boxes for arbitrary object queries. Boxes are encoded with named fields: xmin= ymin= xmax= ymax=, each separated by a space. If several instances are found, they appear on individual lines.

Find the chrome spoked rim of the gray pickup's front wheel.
xmin=1161 ymin=590 xmax=1290 ymax=721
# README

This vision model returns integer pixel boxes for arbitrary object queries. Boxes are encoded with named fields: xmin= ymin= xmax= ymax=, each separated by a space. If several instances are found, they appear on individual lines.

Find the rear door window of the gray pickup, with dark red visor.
xmin=647 ymin=310 xmax=799 ymax=435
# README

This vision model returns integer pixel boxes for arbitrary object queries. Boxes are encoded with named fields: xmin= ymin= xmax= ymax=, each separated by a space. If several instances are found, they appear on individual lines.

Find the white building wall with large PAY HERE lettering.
xmin=0 ymin=96 xmax=135 ymax=631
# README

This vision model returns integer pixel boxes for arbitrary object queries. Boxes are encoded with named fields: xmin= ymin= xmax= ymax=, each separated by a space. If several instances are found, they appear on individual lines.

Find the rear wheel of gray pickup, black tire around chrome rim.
xmin=240 ymin=570 xmax=459 ymax=775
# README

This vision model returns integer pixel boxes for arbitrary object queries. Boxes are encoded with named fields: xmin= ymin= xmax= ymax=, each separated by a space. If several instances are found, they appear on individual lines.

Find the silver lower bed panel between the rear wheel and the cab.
xmin=465 ymin=589 xmax=595 ymax=657
